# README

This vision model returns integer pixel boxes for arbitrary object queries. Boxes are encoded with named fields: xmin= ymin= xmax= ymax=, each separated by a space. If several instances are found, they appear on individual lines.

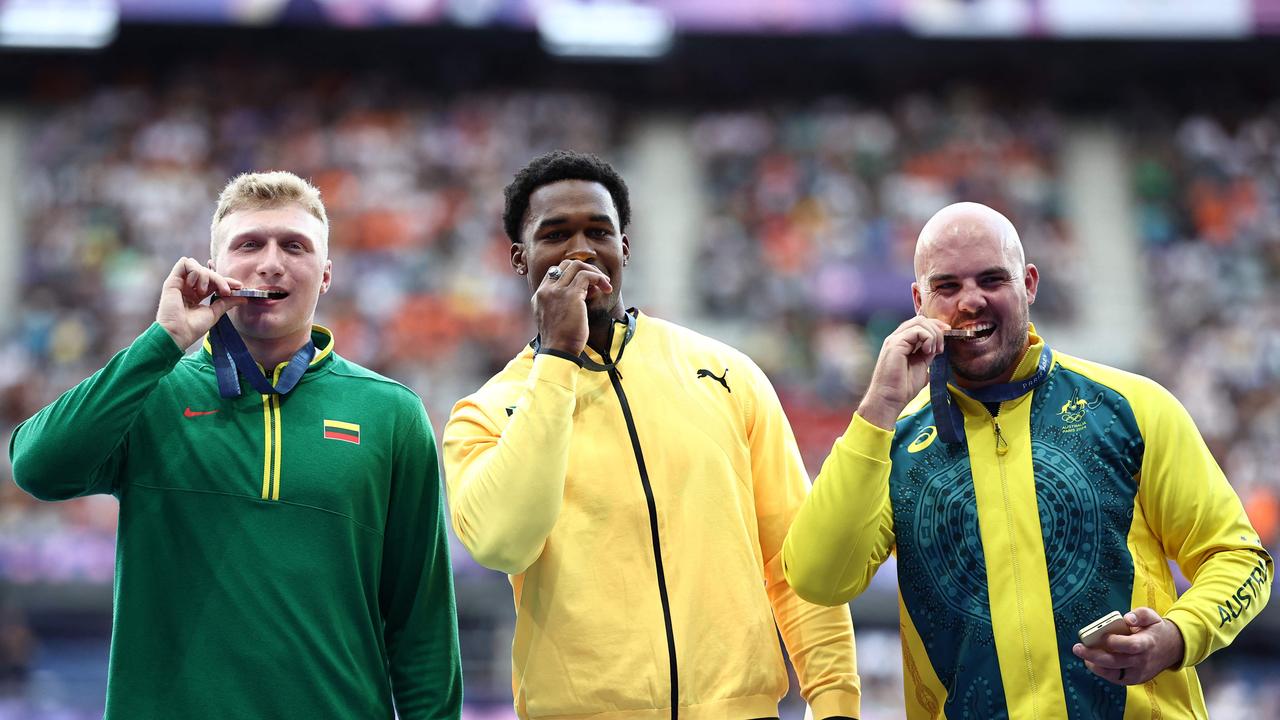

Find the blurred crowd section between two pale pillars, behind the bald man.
xmin=690 ymin=90 xmax=1076 ymax=470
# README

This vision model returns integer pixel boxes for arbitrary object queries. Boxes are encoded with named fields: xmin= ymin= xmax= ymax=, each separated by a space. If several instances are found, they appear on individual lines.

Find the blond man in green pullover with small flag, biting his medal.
xmin=9 ymin=173 xmax=462 ymax=720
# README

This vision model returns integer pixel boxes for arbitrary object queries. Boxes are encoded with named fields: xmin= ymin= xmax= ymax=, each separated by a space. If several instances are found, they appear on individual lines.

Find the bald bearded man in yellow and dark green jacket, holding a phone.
xmin=783 ymin=198 xmax=1272 ymax=719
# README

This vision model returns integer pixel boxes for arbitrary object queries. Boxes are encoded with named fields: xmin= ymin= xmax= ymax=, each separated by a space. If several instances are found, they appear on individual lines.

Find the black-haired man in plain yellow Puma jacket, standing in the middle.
xmin=444 ymin=152 xmax=859 ymax=720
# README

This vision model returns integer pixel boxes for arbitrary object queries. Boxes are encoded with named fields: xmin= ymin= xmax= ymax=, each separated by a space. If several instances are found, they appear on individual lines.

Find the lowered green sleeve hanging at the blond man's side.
xmin=379 ymin=402 xmax=462 ymax=720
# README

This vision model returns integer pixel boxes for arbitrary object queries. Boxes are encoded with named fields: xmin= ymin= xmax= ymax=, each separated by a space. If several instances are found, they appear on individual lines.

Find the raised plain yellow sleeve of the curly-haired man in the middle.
xmin=444 ymin=355 xmax=579 ymax=575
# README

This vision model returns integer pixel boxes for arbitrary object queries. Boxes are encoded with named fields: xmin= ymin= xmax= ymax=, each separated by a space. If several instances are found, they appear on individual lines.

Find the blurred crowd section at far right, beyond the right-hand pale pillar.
xmin=1133 ymin=108 xmax=1280 ymax=550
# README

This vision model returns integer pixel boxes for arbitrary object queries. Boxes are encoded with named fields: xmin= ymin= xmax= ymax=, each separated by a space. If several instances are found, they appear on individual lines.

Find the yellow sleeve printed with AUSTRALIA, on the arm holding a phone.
xmin=1132 ymin=383 xmax=1274 ymax=666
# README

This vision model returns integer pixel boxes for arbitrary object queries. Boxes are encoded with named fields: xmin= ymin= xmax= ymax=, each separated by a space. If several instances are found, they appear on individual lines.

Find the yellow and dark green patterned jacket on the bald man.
xmin=783 ymin=334 xmax=1272 ymax=720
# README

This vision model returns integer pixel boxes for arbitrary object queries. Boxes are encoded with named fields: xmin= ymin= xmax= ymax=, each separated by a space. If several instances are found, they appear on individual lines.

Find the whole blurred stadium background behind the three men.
xmin=0 ymin=0 xmax=1280 ymax=720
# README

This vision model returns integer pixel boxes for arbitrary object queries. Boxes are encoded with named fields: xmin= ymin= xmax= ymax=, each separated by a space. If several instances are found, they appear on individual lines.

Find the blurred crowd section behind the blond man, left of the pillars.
xmin=0 ymin=67 xmax=614 ymax=583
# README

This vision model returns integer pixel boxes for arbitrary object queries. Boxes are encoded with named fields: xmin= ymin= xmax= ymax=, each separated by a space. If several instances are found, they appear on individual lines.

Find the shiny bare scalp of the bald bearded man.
xmin=915 ymin=202 xmax=1027 ymax=283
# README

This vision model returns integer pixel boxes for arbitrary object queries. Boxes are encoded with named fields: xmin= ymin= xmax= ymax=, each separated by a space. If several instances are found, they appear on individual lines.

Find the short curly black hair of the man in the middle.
xmin=502 ymin=150 xmax=631 ymax=242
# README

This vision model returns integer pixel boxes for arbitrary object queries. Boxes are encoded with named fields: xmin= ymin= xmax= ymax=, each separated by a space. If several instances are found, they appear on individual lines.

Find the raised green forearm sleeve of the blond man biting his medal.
xmin=9 ymin=323 xmax=182 ymax=500
